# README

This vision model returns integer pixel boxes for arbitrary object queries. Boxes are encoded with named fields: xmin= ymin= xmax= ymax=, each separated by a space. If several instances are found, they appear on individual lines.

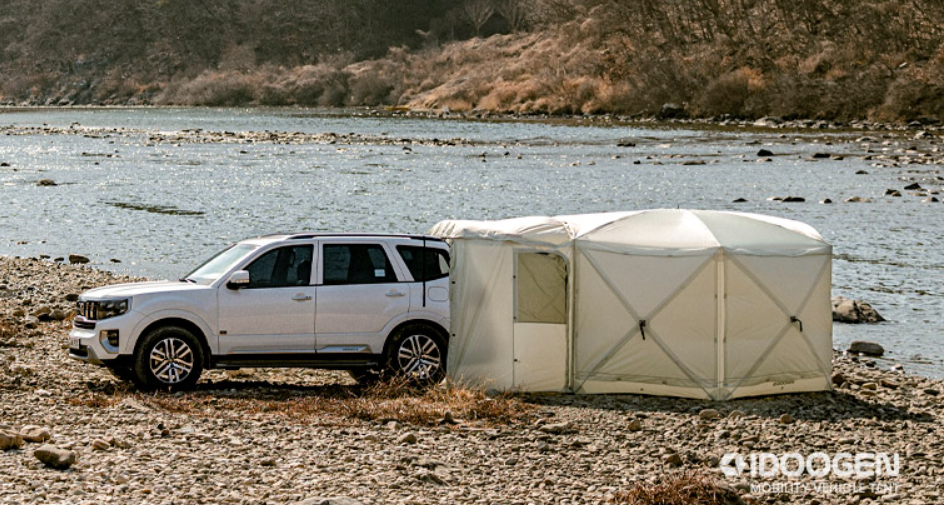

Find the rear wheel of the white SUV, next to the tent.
xmin=387 ymin=324 xmax=446 ymax=384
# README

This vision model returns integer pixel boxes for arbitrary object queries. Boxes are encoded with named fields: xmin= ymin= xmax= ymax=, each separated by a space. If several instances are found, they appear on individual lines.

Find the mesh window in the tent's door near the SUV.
xmin=515 ymin=253 xmax=567 ymax=324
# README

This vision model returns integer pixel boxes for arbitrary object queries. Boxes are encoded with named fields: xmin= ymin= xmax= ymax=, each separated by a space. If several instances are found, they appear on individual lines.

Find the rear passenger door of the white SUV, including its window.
xmin=315 ymin=239 xmax=410 ymax=354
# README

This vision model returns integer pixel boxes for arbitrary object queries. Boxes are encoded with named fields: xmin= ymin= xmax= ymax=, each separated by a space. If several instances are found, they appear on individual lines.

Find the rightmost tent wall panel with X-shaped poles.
xmin=722 ymin=250 xmax=832 ymax=399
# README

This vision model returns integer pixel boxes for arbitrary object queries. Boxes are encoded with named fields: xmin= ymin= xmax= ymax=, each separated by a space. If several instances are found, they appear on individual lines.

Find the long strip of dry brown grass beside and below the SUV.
xmin=68 ymin=378 xmax=535 ymax=426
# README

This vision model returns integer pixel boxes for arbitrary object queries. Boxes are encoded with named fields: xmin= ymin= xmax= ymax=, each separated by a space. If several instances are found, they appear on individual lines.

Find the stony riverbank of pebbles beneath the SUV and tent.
xmin=0 ymin=258 xmax=944 ymax=505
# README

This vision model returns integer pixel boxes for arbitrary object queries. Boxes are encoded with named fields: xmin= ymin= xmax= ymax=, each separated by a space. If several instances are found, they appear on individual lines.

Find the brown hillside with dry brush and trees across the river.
xmin=0 ymin=0 xmax=944 ymax=122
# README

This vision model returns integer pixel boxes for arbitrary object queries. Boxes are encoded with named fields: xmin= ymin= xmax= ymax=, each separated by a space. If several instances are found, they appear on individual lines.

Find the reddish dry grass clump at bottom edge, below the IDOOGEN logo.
xmin=611 ymin=471 xmax=759 ymax=505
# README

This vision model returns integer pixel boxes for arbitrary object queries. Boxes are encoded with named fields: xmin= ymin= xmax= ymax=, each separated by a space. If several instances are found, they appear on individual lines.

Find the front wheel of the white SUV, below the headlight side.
xmin=134 ymin=326 xmax=203 ymax=391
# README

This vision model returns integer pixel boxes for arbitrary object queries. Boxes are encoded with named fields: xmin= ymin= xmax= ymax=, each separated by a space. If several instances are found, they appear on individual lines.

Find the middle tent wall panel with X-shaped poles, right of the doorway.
xmin=574 ymin=246 xmax=720 ymax=399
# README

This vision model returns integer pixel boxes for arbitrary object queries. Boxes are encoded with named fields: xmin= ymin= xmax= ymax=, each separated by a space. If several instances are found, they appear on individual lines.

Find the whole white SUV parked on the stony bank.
xmin=69 ymin=233 xmax=449 ymax=390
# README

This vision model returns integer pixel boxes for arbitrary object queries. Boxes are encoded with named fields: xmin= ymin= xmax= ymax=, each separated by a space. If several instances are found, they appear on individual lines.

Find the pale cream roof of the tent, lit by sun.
xmin=431 ymin=209 xmax=830 ymax=255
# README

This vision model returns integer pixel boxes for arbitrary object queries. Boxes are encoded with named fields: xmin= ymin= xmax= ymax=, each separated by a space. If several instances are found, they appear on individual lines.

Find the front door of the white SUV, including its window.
xmin=219 ymin=244 xmax=316 ymax=354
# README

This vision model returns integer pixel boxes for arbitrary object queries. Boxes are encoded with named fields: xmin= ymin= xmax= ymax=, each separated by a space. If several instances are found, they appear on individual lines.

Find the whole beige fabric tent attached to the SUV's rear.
xmin=431 ymin=210 xmax=832 ymax=400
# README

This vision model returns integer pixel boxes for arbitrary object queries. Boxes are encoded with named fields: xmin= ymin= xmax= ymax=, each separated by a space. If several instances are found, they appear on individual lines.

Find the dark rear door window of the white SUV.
xmin=322 ymin=244 xmax=397 ymax=285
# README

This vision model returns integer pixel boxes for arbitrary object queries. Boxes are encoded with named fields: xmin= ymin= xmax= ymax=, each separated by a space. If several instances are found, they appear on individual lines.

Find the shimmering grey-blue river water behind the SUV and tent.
xmin=0 ymin=109 xmax=944 ymax=377
